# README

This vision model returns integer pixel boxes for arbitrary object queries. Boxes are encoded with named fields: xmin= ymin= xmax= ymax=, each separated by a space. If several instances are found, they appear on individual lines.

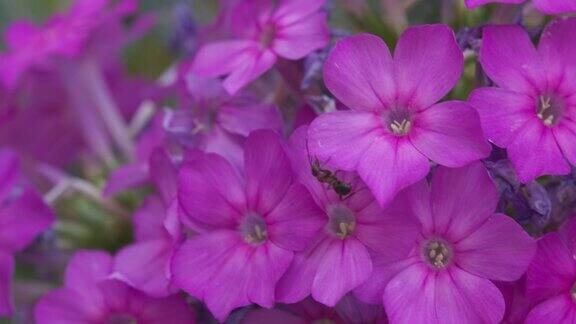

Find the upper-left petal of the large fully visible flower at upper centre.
xmin=324 ymin=34 xmax=395 ymax=111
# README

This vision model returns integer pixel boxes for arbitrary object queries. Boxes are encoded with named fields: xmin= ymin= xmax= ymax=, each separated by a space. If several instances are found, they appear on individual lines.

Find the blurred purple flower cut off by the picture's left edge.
xmin=0 ymin=150 xmax=54 ymax=315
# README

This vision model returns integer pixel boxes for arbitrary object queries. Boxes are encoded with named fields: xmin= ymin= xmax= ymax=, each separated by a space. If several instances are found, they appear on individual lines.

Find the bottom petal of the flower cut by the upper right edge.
xmin=508 ymin=122 xmax=570 ymax=183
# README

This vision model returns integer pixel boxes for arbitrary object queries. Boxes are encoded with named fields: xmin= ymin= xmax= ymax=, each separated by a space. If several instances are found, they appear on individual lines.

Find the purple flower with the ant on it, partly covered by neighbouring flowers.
xmin=276 ymin=127 xmax=418 ymax=306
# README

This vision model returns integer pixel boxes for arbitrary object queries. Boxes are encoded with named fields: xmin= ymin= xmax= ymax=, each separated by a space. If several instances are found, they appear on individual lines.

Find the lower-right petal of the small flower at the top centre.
xmin=272 ymin=12 xmax=330 ymax=60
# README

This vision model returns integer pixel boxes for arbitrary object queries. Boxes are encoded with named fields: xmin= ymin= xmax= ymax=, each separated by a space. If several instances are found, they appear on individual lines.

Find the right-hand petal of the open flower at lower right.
xmin=455 ymin=214 xmax=536 ymax=281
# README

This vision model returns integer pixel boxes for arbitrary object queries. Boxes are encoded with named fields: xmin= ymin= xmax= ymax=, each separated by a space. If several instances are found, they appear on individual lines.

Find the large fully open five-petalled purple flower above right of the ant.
xmin=308 ymin=25 xmax=490 ymax=205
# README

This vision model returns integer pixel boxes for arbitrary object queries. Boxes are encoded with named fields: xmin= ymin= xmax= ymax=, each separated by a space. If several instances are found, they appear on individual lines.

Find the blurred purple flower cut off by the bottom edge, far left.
xmin=34 ymin=251 xmax=195 ymax=324
